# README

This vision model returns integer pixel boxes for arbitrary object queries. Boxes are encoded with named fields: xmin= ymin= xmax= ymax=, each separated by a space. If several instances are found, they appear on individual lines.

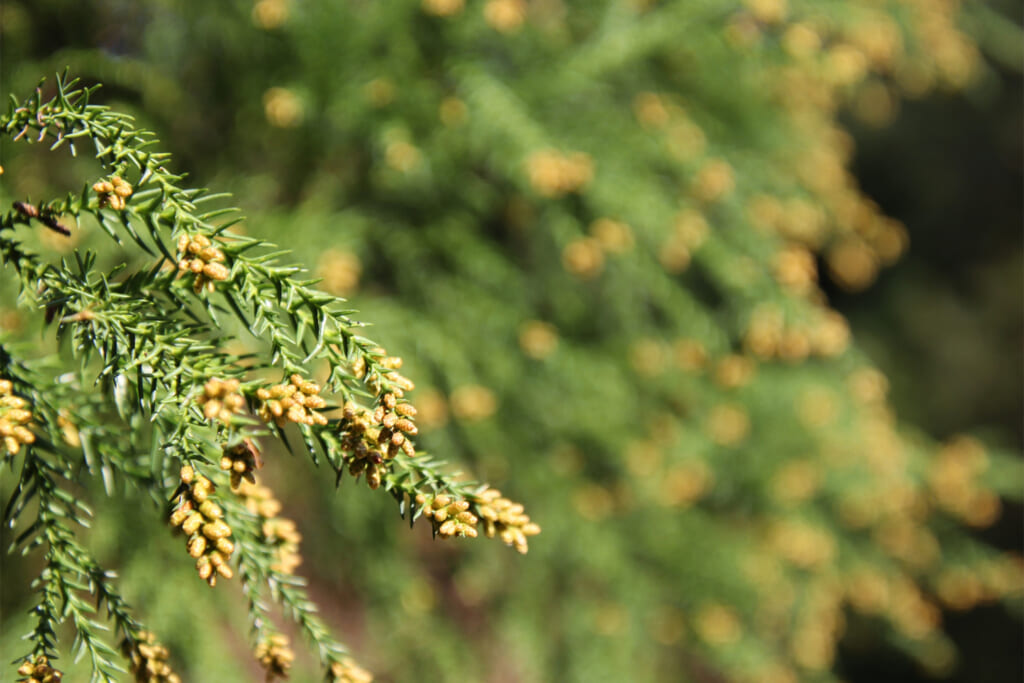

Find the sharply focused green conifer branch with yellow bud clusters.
xmin=0 ymin=72 xmax=540 ymax=681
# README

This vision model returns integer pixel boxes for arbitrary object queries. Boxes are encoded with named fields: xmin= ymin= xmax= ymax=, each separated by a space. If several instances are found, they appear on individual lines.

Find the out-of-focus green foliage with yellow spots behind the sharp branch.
xmin=0 ymin=0 xmax=1024 ymax=681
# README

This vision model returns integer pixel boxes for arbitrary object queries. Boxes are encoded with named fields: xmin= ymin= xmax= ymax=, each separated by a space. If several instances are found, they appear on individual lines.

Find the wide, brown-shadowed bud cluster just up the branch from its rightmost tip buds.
xmin=340 ymin=392 xmax=419 ymax=488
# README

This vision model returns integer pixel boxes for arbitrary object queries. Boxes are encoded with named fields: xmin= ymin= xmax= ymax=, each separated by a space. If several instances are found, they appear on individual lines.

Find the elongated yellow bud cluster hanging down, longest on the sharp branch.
xmin=171 ymin=465 xmax=234 ymax=587
